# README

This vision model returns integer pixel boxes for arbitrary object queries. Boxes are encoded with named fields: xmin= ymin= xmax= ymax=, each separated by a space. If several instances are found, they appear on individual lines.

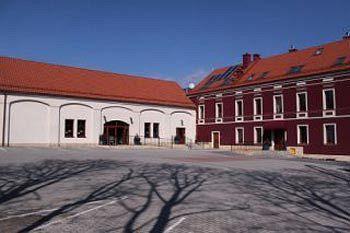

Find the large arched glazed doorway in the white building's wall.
xmin=103 ymin=121 xmax=129 ymax=145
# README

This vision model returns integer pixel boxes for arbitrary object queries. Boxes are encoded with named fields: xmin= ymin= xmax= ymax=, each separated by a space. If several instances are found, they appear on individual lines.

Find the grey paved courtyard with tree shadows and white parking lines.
xmin=0 ymin=148 xmax=350 ymax=233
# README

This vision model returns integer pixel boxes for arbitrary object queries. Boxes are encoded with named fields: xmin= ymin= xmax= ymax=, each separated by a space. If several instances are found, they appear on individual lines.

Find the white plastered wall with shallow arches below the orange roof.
xmin=0 ymin=95 xmax=196 ymax=146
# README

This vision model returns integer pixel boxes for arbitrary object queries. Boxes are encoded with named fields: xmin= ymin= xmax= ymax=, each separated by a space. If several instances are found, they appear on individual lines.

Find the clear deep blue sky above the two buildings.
xmin=0 ymin=0 xmax=350 ymax=85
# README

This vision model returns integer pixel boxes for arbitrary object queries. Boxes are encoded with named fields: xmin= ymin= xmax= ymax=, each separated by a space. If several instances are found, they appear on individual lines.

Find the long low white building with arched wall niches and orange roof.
xmin=0 ymin=57 xmax=196 ymax=146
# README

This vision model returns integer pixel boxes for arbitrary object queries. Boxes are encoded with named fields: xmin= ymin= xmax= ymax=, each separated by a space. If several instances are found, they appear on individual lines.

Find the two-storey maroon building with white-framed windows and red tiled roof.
xmin=188 ymin=36 xmax=350 ymax=155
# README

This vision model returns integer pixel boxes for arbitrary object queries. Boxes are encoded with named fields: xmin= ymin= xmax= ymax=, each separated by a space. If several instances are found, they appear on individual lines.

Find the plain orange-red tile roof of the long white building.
xmin=0 ymin=57 xmax=194 ymax=108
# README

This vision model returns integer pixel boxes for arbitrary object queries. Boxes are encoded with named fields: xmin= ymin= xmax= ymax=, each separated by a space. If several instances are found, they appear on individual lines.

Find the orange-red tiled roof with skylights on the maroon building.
xmin=189 ymin=38 xmax=350 ymax=94
